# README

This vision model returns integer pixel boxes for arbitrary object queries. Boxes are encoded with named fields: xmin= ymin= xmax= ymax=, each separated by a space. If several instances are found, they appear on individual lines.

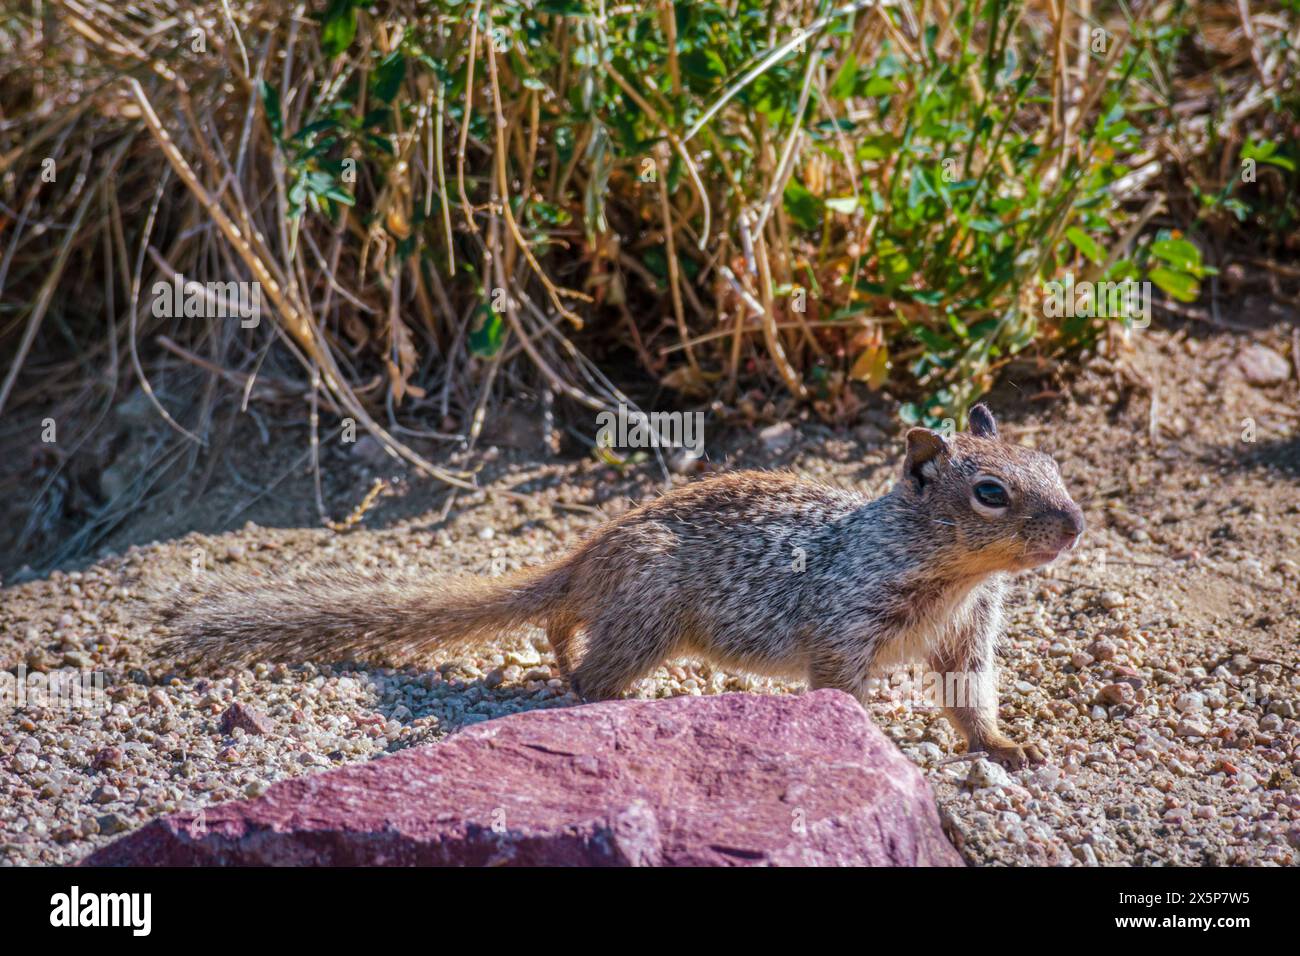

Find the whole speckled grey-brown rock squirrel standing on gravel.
xmin=163 ymin=405 xmax=1083 ymax=766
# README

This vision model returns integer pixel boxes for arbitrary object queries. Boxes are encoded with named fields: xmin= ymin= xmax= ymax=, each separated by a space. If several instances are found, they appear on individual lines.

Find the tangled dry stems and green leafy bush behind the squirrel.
xmin=0 ymin=0 xmax=1297 ymax=441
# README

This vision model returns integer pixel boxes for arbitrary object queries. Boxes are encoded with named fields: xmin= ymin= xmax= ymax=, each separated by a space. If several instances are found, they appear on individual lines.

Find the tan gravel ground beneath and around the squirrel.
xmin=0 ymin=323 xmax=1300 ymax=865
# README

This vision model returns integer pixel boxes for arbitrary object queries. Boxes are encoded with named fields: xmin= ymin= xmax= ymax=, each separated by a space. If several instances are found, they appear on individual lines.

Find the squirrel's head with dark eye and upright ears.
xmin=901 ymin=405 xmax=1083 ymax=571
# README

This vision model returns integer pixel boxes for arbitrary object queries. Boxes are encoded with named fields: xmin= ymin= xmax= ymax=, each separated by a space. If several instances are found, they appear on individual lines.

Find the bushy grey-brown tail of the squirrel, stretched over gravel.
xmin=160 ymin=566 xmax=567 ymax=665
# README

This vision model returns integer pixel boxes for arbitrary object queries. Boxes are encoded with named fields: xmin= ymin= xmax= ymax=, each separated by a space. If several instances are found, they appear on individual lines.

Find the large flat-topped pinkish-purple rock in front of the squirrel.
xmin=85 ymin=691 xmax=962 ymax=866
